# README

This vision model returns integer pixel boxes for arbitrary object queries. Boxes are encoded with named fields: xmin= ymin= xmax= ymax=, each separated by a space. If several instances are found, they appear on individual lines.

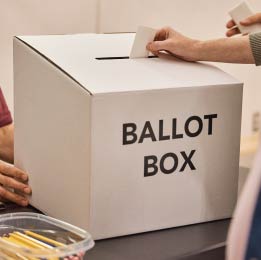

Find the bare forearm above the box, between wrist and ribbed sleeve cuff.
xmin=195 ymin=36 xmax=255 ymax=64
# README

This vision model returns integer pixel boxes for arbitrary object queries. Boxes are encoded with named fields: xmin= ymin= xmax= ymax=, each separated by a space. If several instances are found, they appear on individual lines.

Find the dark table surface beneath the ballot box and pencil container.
xmin=0 ymin=204 xmax=230 ymax=260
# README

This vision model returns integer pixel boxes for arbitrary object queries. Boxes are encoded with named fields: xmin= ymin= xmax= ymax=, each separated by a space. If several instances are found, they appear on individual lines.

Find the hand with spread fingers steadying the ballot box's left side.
xmin=0 ymin=161 xmax=32 ymax=207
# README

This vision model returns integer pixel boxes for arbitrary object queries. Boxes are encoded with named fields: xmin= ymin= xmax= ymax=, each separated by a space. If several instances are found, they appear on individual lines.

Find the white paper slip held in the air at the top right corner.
xmin=229 ymin=1 xmax=261 ymax=34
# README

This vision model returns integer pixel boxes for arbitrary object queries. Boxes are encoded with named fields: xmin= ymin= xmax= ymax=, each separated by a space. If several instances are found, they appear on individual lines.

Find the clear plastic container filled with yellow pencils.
xmin=0 ymin=212 xmax=94 ymax=260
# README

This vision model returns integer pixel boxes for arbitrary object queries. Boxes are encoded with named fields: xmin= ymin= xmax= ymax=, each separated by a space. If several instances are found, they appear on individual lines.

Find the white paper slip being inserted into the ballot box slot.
xmin=130 ymin=26 xmax=156 ymax=59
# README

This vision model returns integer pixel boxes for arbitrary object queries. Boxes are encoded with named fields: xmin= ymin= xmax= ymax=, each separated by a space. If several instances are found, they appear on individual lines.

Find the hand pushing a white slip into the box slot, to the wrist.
xmin=147 ymin=27 xmax=199 ymax=61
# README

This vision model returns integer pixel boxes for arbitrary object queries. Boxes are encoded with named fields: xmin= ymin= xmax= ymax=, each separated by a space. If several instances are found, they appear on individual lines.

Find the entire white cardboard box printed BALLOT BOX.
xmin=14 ymin=34 xmax=242 ymax=239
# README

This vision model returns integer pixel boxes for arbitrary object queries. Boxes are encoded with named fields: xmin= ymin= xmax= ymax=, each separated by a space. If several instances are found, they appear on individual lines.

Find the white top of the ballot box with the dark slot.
xmin=17 ymin=33 xmax=239 ymax=94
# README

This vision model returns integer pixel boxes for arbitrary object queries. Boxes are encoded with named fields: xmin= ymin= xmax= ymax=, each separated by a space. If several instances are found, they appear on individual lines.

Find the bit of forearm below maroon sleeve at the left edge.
xmin=0 ymin=124 xmax=14 ymax=163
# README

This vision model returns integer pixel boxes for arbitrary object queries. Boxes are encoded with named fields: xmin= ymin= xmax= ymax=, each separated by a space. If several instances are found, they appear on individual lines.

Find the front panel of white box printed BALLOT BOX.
xmin=91 ymin=84 xmax=242 ymax=239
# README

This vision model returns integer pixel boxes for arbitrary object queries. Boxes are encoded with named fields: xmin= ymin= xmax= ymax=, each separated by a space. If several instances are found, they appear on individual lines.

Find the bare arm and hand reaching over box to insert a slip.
xmin=147 ymin=27 xmax=254 ymax=64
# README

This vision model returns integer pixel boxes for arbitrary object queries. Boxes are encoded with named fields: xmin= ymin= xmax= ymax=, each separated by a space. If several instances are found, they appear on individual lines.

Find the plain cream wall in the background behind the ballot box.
xmin=0 ymin=0 xmax=261 ymax=135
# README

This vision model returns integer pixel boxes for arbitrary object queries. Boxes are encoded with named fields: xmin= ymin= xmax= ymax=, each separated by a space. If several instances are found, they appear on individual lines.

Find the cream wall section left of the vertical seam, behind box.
xmin=0 ymin=0 xmax=97 ymax=111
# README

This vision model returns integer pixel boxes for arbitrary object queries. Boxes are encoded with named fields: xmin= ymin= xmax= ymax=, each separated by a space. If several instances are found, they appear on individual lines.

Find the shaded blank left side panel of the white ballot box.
xmin=14 ymin=39 xmax=91 ymax=228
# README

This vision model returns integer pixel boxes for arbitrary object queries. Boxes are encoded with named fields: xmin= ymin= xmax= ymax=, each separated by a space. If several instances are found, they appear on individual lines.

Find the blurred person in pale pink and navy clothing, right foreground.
xmin=227 ymin=142 xmax=261 ymax=260
